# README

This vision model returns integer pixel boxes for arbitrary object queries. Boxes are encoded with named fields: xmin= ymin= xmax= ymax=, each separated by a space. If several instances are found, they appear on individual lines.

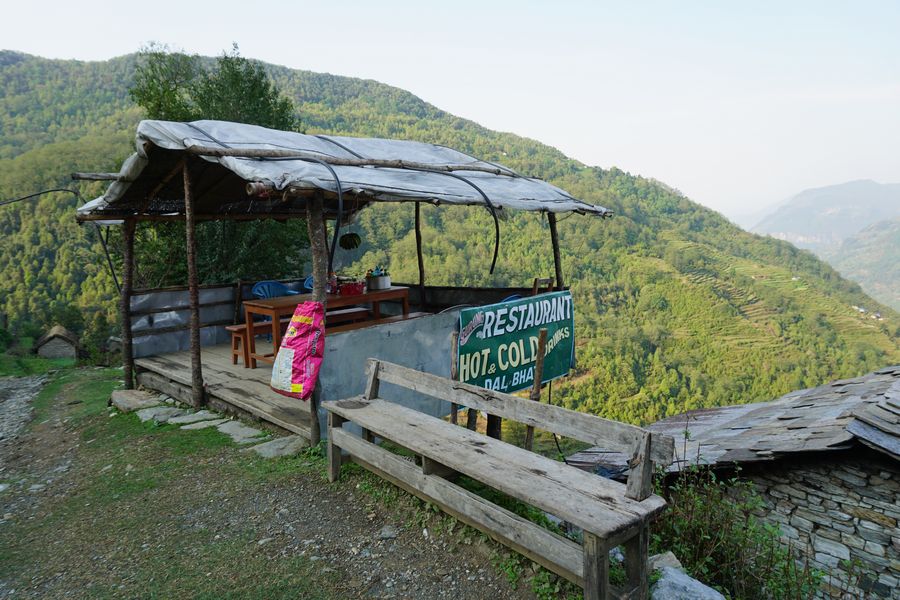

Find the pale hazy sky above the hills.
xmin=0 ymin=0 xmax=900 ymax=216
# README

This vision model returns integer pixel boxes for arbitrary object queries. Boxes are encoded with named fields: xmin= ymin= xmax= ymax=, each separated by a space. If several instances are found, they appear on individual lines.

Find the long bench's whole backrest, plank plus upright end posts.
xmin=363 ymin=358 xmax=675 ymax=499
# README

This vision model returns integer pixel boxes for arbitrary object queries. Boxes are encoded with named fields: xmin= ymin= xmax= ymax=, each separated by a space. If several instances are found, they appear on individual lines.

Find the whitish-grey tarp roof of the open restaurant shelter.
xmin=77 ymin=121 xmax=611 ymax=220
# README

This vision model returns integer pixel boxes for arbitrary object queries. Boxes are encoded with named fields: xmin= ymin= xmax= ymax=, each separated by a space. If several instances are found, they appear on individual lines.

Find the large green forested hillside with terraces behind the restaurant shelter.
xmin=0 ymin=52 xmax=900 ymax=422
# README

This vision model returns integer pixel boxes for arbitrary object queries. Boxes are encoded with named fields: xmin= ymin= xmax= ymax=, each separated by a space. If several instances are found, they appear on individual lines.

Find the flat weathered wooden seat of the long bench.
xmin=324 ymin=398 xmax=665 ymax=541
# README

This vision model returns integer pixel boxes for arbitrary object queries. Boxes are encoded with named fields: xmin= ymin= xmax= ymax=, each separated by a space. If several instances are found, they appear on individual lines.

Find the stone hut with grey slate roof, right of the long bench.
xmin=569 ymin=366 xmax=900 ymax=600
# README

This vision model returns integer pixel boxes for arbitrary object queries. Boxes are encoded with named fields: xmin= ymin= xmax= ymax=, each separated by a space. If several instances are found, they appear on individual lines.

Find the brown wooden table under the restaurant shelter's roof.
xmin=244 ymin=285 xmax=409 ymax=369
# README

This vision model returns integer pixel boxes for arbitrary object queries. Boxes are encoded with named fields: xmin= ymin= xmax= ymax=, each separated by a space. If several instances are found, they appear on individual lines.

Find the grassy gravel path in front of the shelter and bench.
xmin=0 ymin=371 xmax=534 ymax=600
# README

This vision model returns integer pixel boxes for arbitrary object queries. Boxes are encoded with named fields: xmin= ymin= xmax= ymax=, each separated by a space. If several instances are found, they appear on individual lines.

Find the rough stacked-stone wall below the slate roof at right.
xmin=741 ymin=449 xmax=900 ymax=600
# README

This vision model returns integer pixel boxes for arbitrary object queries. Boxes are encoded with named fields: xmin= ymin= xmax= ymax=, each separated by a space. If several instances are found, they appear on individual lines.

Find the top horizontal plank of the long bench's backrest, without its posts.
xmin=370 ymin=359 xmax=675 ymax=466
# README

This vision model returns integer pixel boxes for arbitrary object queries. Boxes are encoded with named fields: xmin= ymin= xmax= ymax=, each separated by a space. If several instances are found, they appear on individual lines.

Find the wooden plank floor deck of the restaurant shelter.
xmin=135 ymin=344 xmax=310 ymax=439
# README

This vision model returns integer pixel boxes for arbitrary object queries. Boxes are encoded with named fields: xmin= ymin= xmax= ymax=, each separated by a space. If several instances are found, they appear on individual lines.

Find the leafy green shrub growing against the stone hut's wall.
xmin=652 ymin=467 xmax=821 ymax=600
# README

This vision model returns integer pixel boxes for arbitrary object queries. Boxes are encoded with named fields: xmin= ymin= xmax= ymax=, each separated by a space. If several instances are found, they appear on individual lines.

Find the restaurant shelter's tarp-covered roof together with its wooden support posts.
xmin=73 ymin=121 xmax=611 ymax=442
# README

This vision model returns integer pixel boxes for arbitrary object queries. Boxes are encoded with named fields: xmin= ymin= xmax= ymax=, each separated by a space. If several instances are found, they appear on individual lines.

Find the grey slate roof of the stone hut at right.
xmin=570 ymin=365 xmax=900 ymax=471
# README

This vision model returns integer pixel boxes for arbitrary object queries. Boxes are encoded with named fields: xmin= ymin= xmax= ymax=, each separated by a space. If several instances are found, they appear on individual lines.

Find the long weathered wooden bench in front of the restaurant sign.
xmin=322 ymin=359 xmax=674 ymax=600
